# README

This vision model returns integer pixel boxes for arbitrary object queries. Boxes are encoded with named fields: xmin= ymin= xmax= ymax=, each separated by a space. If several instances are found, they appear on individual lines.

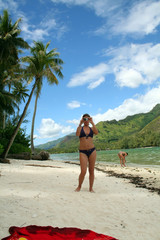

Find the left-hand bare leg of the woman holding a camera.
xmin=75 ymin=153 xmax=88 ymax=192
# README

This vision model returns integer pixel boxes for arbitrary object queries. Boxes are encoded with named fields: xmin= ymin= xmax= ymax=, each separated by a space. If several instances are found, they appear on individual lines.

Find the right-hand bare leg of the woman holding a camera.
xmin=89 ymin=150 xmax=97 ymax=192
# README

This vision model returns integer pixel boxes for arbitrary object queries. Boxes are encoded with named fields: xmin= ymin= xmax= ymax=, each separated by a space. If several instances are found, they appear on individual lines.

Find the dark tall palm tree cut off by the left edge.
xmin=0 ymin=10 xmax=29 ymax=129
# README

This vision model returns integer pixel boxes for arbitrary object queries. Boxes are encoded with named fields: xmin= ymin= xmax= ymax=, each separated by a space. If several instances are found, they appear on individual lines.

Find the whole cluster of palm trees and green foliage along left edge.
xmin=0 ymin=10 xmax=63 ymax=159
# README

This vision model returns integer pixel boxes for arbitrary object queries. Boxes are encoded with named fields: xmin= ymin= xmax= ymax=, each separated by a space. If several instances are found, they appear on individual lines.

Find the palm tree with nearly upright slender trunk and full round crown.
xmin=24 ymin=42 xmax=63 ymax=154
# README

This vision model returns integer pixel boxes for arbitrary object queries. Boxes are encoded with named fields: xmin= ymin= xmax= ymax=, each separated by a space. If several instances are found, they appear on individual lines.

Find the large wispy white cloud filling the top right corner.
xmin=52 ymin=0 xmax=160 ymax=35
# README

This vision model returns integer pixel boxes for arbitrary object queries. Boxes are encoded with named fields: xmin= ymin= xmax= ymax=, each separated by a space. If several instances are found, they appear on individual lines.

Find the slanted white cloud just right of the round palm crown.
xmin=68 ymin=63 xmax=108 ymax=89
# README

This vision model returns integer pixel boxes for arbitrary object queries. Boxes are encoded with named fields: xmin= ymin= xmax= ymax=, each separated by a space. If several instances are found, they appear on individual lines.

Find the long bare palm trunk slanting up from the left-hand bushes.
xmin=2 ymin=81 xmax=37 ymax=160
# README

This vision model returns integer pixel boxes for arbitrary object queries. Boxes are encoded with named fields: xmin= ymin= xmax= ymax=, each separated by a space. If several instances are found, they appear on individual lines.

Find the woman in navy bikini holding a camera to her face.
xmin=75 ymin=113 xmax=98 ymax=192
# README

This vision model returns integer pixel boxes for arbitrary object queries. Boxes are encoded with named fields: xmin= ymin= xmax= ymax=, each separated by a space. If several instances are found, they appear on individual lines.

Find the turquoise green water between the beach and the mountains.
xmin=50 ymin=147 xmax=160 ymax=166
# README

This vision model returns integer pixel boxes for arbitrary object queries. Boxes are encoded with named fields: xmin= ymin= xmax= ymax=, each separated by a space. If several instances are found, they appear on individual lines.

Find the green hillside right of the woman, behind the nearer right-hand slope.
xmin=95 ymin=104 xmax=160 ymax=149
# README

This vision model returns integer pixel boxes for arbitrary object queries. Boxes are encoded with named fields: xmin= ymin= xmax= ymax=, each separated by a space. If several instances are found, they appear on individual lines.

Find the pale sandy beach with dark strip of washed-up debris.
xmin=0 ymin=159 xmax=160 ymax=240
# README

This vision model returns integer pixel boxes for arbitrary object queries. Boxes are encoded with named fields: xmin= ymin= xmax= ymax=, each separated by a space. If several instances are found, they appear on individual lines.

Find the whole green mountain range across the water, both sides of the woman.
xmin=36 ymin=104 xmax=160 ymax=153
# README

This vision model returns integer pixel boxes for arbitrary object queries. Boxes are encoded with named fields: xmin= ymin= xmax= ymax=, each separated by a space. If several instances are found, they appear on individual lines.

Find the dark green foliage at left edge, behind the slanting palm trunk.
xmin=0 ymin=10 xmax=29 ymax=158
